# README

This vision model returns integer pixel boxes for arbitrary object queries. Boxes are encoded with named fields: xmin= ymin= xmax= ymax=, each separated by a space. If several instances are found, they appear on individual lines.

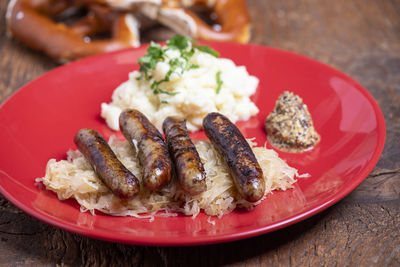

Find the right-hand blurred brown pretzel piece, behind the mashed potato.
xmin=93 ymin=0 xmax=250 ymax=43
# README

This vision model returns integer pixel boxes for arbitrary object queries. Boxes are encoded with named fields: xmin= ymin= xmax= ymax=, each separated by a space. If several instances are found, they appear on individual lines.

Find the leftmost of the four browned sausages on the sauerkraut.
xmin=74 ymin=129 xmax=140 ymax=199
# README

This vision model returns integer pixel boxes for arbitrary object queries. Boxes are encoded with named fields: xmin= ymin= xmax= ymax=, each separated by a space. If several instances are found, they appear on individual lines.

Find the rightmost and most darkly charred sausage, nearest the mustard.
xmin=203 ymin=112 xmax=265 ymax=202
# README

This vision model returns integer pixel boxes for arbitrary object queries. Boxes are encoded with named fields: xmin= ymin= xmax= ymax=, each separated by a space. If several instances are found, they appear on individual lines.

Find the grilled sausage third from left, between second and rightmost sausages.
xmin=163 ymin=117 xmax=207 ymax=195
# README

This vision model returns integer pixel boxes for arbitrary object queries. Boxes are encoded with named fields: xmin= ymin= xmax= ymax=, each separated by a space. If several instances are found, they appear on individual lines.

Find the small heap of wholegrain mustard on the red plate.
xmin=265 ymin=91 xmax=321 ymax=152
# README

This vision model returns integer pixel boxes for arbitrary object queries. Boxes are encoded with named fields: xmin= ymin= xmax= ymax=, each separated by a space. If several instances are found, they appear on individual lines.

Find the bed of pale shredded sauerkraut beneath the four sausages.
xmin=36 ymin=137 xmax=299 ymax=220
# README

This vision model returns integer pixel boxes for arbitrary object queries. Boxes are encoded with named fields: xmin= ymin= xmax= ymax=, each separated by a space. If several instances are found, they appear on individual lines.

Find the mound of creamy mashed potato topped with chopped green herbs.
xmin=101 ymin=35 xmax=259 ymax=132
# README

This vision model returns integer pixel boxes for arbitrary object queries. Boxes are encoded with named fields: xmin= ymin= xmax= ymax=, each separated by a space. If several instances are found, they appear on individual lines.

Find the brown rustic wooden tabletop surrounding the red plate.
xmin=0 ymin=0 xmax=400 ymax=266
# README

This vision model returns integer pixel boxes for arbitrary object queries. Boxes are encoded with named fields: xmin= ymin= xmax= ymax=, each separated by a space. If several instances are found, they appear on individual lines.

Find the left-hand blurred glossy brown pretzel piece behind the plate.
xmin=6 ymin=0 xmax=140 ymax=62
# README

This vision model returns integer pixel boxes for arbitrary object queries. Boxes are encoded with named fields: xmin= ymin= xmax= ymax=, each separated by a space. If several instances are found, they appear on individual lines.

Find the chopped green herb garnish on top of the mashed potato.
xmin=137 ymin=35 xmax=222 ymax=96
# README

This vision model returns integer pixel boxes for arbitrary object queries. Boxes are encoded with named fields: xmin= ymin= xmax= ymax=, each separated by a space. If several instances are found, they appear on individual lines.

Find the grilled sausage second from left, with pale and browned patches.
xmin=119 ymin=109 xmax=172 ymax=190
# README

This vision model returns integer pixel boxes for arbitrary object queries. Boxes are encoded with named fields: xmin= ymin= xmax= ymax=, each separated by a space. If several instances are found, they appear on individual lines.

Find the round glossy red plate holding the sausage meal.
xmin=0 ymin=43 xmax=385 ymax=246
